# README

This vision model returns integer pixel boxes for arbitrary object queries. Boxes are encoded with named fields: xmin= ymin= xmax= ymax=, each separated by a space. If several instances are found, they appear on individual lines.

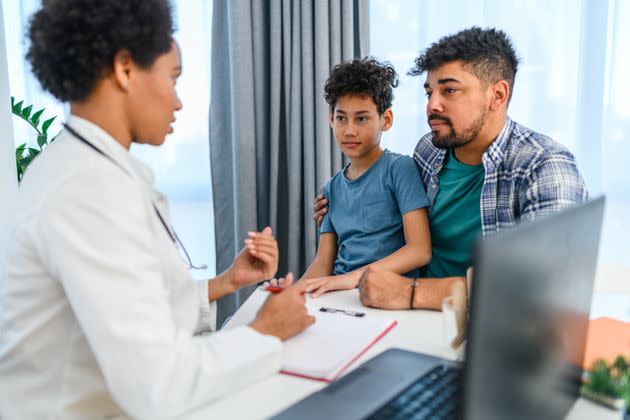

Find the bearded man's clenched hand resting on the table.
xmin=359 ymin=266 xmax=411 ymax=309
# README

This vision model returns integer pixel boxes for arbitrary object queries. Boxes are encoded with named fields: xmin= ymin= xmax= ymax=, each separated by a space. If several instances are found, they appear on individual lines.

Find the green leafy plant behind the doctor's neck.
xmin=11 ymin=96 xmax=57 ymax=181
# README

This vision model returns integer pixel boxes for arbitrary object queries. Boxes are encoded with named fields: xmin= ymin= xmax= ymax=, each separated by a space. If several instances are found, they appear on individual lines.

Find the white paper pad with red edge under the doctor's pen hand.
xmin=280 ymin=308 xmax=396 ymax=382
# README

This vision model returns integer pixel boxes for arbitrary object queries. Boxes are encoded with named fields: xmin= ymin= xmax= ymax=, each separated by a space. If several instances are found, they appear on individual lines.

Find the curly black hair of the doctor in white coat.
xmin=26 ymin=0 xmax=174 ymax=102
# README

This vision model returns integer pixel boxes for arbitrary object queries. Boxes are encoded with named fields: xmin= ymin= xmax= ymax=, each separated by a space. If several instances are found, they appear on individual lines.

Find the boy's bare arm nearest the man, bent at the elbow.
xmin=370 ymin=209 xmax=431 ymax=274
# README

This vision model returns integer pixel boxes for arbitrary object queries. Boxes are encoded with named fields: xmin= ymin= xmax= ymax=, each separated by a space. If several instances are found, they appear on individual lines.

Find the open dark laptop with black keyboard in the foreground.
xmin=275 ymin=197 xmax=605 ymax=420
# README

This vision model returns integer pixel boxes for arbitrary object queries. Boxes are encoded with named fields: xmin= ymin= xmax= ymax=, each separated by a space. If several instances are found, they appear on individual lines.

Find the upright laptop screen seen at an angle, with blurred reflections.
xmin=463 ymin=198 xmax=604 ymax=419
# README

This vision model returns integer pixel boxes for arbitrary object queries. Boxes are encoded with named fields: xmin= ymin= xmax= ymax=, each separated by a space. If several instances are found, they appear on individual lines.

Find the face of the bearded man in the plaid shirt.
xmin=424 ymin=61 xmax=489 ymax=149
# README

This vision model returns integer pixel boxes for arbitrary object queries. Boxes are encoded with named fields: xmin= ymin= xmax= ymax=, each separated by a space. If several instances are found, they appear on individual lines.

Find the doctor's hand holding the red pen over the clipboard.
xmin=249 ymin=273 xmax=315 ymax=340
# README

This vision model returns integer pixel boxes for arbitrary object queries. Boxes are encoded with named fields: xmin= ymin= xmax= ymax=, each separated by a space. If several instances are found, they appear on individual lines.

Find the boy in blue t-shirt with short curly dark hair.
xmin=302 ymin=58 xmax=431 ymax=297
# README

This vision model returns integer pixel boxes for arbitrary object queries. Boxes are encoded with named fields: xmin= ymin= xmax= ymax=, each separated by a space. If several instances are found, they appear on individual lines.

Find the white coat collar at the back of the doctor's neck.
xmin=66 ymin=115 xmax=155 ymax=185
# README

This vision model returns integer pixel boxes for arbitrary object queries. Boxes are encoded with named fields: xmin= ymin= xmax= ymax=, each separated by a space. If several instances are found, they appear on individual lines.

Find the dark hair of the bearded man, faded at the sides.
xmin=408 ymin=26 xmax=519 ymax=101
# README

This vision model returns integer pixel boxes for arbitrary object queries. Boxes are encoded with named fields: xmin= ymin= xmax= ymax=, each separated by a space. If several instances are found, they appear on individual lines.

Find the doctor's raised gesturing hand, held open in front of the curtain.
xmin=228 ymin=226 xmax=279 ymax=289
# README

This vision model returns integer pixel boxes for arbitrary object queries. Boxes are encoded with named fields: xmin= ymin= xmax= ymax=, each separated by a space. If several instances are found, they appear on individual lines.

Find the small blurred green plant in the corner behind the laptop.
xmin=584 ymin=355 xmax=630 ymax=413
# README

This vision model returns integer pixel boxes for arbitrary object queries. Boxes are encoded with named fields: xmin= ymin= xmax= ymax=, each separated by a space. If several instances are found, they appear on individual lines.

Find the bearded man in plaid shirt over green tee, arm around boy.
xmin=314 ymin=27 xmax=587 ymax=309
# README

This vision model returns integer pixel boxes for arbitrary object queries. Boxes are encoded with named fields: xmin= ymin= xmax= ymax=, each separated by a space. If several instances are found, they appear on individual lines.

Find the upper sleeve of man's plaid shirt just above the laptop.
xmin=518 ymin=151 xmax=588 ymax=221
